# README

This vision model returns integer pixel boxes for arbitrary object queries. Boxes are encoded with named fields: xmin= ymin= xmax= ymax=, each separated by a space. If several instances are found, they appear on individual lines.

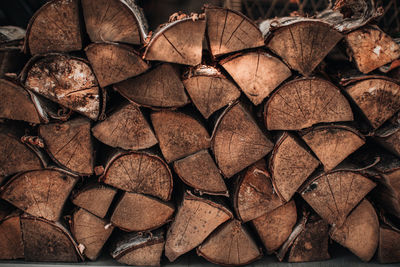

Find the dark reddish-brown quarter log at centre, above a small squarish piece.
xmin=151 ymin=110 xmax=210 ymax=163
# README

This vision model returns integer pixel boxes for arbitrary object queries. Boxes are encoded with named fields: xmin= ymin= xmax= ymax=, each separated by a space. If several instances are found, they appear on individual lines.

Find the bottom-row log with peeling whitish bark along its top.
xmin=111 ymin=229 xmax=165 ymax=266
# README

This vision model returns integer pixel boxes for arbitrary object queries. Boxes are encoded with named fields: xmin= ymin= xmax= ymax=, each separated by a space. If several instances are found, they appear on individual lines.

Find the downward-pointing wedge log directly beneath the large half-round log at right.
xmin=302 ymin=125 xmax=365 ymax=171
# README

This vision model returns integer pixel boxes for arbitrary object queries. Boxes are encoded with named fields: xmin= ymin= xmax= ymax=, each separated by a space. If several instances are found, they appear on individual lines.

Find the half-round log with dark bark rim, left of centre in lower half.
xmin=101 ymin=152 xmax=173 ymax=201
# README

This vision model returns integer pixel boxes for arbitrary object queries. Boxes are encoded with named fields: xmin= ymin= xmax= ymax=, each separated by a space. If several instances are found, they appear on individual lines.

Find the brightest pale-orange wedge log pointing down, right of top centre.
xmin=220 ymin=51 xmax=292 ymax=105
